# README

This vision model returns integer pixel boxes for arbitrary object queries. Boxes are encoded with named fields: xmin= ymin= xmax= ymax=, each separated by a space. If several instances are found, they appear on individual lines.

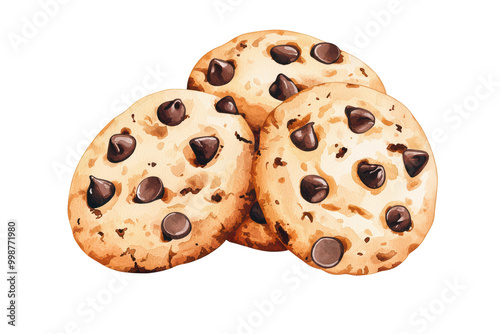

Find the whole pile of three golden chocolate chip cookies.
xmin=68 ymin=31 xmax=437 ymax=275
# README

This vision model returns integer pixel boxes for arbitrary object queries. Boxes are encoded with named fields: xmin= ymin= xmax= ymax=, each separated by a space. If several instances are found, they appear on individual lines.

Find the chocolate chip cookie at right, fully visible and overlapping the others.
xmin=255 ymin=83 xmax=437 ymax=275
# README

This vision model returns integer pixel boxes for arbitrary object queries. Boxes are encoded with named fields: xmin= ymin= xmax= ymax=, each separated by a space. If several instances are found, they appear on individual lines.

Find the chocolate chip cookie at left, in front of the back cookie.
xmin=68 ymin=90 xmax=254 ymax=272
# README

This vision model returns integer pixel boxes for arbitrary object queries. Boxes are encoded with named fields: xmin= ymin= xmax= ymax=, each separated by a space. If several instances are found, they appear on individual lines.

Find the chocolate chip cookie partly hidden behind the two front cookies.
xmin=188 ymin=30 xmax=385 ymax=250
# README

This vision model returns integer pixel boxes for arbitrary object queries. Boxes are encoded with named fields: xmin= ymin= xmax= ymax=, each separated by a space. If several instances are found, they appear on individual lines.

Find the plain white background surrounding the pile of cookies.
xmin=0 ymin=0 xmax=500 ymax=334
